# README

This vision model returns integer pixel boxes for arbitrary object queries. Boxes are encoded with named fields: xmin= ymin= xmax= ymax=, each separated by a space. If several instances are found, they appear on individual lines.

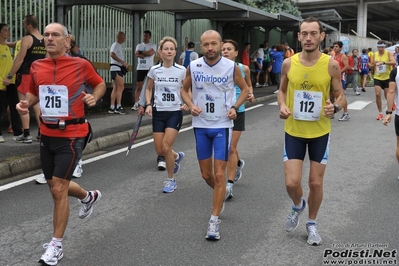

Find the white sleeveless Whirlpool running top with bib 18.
xmin=190 ymin=57 xmax=236 ymax=128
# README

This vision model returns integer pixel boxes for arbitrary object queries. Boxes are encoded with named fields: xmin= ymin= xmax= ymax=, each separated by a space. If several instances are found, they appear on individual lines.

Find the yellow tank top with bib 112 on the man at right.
xmin=284 ymin=54 xmax=331 ymax=138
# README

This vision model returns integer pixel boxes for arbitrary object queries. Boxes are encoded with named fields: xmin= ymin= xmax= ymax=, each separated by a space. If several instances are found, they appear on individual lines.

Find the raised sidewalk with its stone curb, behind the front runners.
xmin=0 ymin=85 xmax=276 ymax=182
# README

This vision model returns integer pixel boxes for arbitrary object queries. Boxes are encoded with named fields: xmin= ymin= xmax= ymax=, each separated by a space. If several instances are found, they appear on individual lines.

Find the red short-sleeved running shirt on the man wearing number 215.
xmin=29 ymin=56 xmax=103 ymax=138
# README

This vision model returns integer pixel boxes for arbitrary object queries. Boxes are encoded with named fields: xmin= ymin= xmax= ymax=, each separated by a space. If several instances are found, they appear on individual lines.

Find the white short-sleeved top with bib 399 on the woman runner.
xmin=147 ymin=63 xmax=186 ymax=111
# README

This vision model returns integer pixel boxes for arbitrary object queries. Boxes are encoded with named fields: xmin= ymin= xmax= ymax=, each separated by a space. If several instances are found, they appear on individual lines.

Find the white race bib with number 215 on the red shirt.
xmin=39 ymin=85 xmax=68 ymax=117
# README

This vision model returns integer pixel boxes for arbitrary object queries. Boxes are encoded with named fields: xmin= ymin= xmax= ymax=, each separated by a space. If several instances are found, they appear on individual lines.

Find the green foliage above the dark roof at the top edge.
xmin=233 ymin=0 xmax=301 ymax=17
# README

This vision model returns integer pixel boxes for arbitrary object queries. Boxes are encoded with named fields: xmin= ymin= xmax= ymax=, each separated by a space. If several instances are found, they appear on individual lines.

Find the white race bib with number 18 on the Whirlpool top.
xmin=198 ymin=93 xmax=227 ymax=120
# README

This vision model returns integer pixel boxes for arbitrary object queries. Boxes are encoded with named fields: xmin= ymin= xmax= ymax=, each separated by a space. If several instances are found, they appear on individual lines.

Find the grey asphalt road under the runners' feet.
xmin=0 ymin=90 xmax=399 ymax=266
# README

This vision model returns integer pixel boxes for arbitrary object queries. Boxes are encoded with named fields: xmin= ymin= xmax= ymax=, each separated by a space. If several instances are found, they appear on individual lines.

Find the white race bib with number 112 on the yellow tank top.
xmin=294 ymin=90 xmax=323 ymax=121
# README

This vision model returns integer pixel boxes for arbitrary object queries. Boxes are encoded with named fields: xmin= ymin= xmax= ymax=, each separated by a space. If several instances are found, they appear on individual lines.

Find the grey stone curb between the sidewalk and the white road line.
xmin=0 ymin=94 xmax=277 ymax=181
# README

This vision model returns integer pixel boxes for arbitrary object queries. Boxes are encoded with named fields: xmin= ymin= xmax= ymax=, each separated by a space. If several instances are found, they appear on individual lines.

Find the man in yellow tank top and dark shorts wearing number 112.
xmin=278 ymin=17 xmax=346 ymax=245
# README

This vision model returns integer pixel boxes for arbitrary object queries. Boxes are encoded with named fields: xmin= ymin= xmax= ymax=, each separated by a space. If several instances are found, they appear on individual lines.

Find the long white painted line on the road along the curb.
xmin=0 ymin=104 xmax=263 ymax=191
